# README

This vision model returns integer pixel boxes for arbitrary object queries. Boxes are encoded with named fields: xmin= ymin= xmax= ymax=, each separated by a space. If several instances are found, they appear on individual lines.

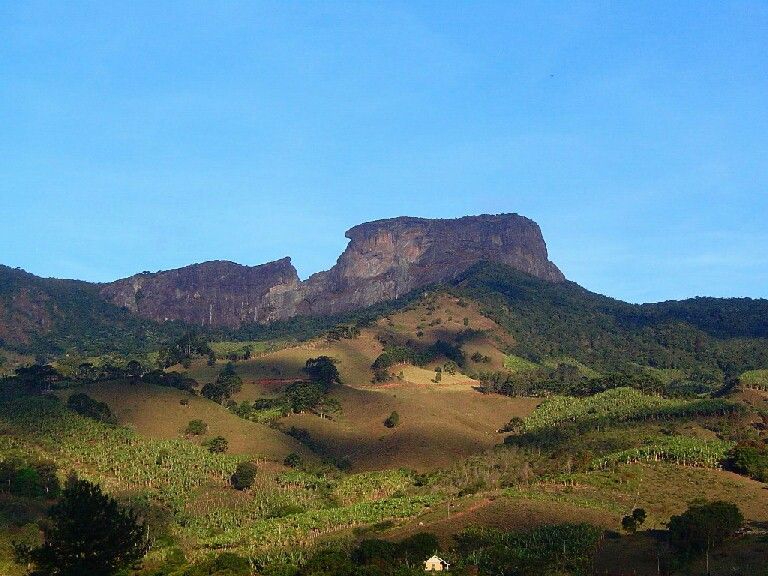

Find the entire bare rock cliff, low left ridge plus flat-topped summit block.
xmin=101 ymin=214 xmax=564 ymax=327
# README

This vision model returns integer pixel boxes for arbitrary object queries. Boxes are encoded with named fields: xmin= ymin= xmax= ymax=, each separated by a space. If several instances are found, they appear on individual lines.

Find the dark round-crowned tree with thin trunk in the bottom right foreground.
xmin=668 ymin=500 xmax=744 ymax=573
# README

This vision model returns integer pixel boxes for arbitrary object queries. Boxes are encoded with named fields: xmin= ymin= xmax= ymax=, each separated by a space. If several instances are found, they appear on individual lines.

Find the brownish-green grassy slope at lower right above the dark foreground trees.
xmin=386 ymin=463 xmax=768 ymax=548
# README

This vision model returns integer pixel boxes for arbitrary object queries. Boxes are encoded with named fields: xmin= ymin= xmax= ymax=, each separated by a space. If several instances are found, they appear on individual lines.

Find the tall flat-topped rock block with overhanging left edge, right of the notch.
xmin=305 ymin=214 xmax=565 ymax=314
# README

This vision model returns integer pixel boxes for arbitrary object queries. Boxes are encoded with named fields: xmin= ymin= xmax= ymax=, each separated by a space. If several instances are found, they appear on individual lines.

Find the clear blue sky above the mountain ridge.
xmin=0 ymin=0 xmax=768 ymax=301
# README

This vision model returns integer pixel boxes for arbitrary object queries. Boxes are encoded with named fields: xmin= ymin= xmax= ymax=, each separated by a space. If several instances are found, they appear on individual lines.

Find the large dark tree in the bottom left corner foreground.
xmin=30 ymin=478 xmax=149 ymax=576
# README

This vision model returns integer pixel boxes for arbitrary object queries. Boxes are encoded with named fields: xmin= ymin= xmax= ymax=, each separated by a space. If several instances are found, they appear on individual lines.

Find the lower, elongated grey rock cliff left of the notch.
xmin=101 ymin=258 xmax=299 ymax=327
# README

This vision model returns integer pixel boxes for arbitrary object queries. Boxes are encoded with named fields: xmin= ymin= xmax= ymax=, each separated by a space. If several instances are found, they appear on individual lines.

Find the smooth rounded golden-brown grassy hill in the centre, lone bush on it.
xmin=272 ymin=382 xmax=537 ymax=471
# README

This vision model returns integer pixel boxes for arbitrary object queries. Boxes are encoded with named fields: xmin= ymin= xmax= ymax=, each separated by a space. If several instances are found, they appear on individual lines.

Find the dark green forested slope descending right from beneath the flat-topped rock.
xmin=451 ymin=263 xmax=768 ymax=378
